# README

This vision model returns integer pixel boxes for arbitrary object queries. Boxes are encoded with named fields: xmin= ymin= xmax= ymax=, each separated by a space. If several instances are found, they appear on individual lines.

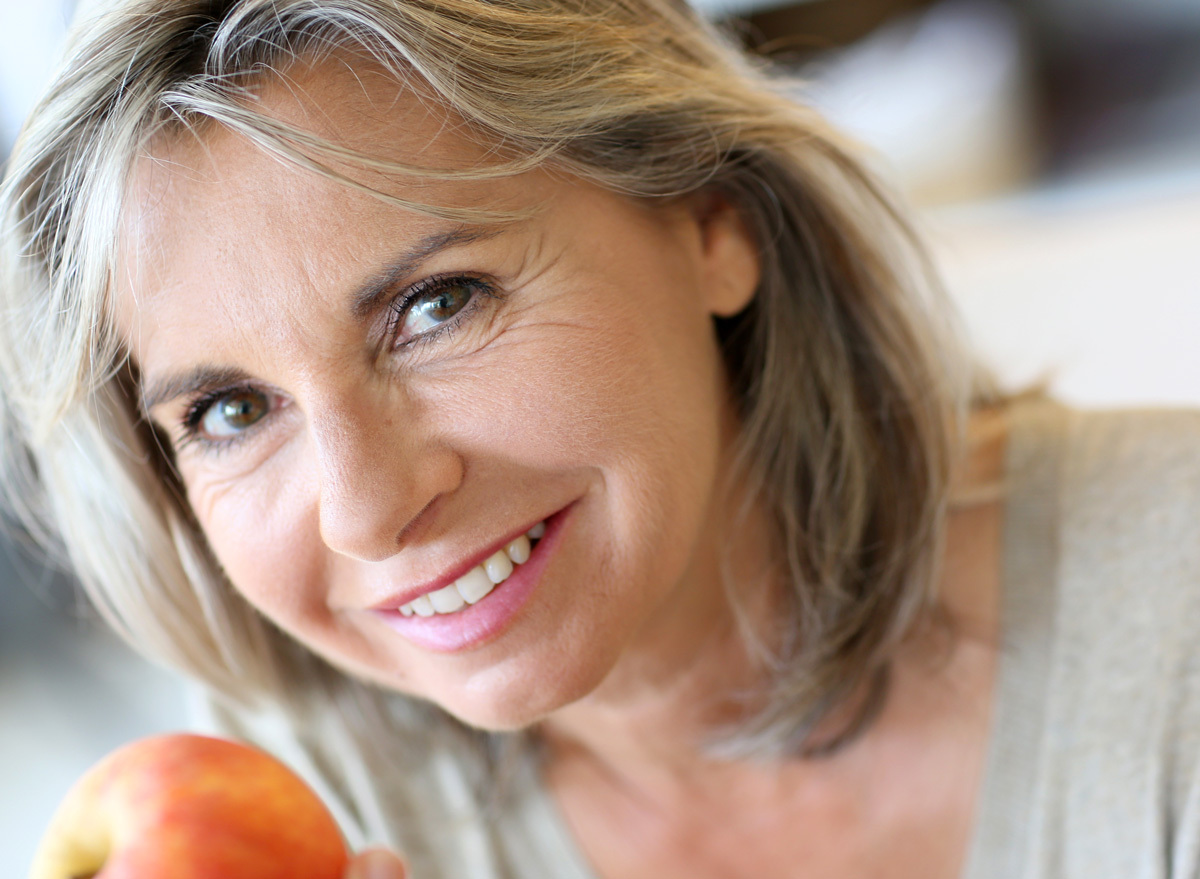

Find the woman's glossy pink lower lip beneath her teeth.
xmin=372 ymin=504 xmax=574 ymax=653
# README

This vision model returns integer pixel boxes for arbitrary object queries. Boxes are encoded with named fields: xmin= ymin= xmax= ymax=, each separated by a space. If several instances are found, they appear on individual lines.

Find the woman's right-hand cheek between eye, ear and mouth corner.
xmin=430 ymin=292 xmax=724 ymax=569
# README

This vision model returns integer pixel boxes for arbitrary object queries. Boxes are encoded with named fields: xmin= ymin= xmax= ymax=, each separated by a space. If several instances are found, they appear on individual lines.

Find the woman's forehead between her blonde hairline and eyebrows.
xmin=114 ymin=58 xmax=532 ymax=343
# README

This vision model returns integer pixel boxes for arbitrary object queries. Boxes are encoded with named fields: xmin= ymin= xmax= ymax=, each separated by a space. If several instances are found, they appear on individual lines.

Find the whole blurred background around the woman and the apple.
xmin=0 ymin=0 xmax=1200 ymax=877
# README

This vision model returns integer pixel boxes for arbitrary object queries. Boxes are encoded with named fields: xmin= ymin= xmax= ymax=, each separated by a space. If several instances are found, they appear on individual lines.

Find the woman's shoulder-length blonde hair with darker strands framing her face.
xmin=0 ymin=0 xmax=972 ymax=754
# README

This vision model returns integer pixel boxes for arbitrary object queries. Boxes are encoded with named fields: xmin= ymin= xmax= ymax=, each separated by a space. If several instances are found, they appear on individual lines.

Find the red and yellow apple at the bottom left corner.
xmin=30 ymin=734 xmax=348 ymax=879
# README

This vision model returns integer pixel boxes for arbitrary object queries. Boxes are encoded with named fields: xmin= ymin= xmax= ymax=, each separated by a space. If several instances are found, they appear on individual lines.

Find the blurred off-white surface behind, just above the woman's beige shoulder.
xmin=928 ymin=164 xmax=1200 ymax=406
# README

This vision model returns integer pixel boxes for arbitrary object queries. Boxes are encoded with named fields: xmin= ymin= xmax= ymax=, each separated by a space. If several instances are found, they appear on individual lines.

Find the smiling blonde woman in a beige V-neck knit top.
xmin=0 ymin=0 xmax=1200 ymax=879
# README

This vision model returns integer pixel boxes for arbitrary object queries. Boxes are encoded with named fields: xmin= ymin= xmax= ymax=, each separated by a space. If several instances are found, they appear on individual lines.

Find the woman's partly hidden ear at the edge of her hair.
xmin=690 ymin=190 xmax=762 ymax=317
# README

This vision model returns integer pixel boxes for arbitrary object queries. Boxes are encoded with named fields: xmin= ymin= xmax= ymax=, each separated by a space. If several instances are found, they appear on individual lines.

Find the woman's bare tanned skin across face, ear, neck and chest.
xmin=116 ymin=61 xmax=1003 ymax=879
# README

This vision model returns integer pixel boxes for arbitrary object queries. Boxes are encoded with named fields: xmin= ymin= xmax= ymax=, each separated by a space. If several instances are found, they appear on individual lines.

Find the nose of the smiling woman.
xmin=310 ymin=391 xmax=463 ymax=562
